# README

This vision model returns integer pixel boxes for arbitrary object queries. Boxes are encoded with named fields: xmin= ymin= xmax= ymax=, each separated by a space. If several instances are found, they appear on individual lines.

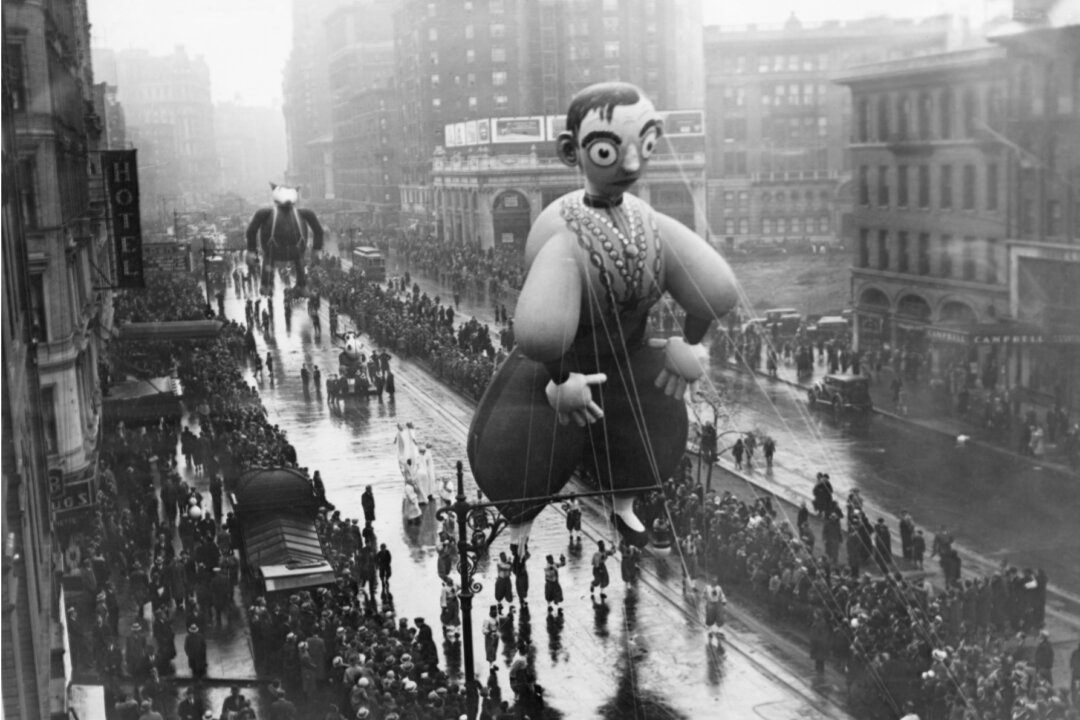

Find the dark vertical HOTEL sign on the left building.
xmin=102 ymin=150 xmax=145 ymax=288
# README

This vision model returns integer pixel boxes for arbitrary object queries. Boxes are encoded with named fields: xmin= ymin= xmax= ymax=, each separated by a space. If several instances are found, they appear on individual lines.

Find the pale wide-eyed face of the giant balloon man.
xmin=576 ymin=97 xmax=661 ymax=200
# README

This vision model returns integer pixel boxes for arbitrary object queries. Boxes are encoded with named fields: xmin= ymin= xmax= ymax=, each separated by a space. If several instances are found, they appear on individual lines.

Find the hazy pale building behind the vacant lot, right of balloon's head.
xmin=704 ymin=16 xmax=950 ymax=246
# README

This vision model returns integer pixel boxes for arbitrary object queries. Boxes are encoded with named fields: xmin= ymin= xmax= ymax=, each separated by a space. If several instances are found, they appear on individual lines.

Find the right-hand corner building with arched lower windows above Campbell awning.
xmin=839 ymin=15 xmax=1080 ymax=406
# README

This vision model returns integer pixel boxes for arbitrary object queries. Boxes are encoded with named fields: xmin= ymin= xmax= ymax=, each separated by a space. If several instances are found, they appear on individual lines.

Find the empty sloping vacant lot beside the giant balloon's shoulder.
xmin=729 ymin=253 xmax=851 ymax=315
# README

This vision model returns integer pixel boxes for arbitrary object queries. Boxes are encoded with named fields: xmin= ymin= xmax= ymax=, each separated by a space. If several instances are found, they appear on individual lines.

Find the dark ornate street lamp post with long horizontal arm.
xmin=435 ymin=460 xmax=663 ymax=720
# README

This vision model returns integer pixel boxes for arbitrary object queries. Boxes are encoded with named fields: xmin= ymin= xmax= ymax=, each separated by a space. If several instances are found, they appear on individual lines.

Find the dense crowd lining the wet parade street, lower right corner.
xmin=638 ymin=463 xmax=1080 ymax=720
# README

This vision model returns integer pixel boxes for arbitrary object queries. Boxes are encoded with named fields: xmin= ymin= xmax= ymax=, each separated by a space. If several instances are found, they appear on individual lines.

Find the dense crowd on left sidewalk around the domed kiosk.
xmin=65 ymin=273 xmax=490 ymax=720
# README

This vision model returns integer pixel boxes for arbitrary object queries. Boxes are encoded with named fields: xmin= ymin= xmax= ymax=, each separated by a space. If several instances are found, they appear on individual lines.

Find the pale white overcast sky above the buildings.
xmin=89 ymin=0 xmax=1010 ymax=105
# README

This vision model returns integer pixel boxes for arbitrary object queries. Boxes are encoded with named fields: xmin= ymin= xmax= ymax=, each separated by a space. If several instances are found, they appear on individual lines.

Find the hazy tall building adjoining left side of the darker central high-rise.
xmin=326 ymin=0 xmax=402 ymax=227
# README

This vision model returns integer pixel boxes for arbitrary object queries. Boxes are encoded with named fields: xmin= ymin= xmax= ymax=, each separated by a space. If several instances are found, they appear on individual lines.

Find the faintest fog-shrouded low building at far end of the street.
xmin=214 ymin=101 xmax=287 ymax=204
